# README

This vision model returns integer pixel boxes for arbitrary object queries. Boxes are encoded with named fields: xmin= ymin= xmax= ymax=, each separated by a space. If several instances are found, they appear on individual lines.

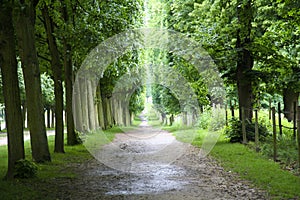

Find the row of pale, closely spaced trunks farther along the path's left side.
xmin=73 ymin=76 xmax=132 ymax=132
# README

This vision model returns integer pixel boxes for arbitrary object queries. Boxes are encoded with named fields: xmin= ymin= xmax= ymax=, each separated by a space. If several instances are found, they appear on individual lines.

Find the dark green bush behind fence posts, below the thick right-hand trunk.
xmin=225 ymin=118 xmax=270 ymax=142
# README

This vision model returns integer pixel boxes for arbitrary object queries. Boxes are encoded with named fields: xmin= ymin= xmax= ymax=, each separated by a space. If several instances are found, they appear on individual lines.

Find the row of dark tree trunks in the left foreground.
xmin=0 ymin=0 xmax=78 ymax=179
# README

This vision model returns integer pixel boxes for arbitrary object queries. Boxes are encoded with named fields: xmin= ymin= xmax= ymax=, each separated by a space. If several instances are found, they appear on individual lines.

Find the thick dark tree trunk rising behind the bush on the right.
xmin=236 ymin=0 xmax=254 ymax=121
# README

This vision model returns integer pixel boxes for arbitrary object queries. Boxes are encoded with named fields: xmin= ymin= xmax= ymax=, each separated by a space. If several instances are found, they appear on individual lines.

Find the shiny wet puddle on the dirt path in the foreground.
xmin=88 ymin=163 xmax=189 ymax=196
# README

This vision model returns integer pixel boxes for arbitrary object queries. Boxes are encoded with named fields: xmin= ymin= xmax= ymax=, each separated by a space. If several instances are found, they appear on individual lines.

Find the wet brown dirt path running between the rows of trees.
xmin=28 ymin=118 xmax=268 ymax=200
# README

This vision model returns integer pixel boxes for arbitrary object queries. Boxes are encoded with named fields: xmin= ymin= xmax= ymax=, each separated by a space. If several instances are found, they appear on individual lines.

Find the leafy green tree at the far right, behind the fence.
xmin=254 ymin=0 xmax=300 ymax=120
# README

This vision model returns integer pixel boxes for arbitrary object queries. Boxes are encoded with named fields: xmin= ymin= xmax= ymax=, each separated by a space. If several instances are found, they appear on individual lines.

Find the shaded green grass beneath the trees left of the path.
xmin=0 ymin=127 xmax=122 ymax=200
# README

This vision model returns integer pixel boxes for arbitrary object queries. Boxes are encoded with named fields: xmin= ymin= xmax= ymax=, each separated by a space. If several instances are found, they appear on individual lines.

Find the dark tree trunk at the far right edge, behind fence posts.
xmin=283 ymin=87 xmax=299 ymax=121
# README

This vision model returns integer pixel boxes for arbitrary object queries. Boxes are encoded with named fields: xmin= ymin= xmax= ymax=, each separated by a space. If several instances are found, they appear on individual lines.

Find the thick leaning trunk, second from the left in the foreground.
xmin=14 ymin=1 xmax=51 ymax=162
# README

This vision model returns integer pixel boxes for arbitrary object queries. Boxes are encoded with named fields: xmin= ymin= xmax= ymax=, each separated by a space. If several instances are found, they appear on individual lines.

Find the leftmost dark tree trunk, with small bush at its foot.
xmin=0 ymin=2 xmax=25 ymax=179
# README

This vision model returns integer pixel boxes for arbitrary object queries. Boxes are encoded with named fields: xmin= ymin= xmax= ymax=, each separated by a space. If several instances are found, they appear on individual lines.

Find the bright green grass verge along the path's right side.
xmin=169 ymin=127 xmax=300 ymax=199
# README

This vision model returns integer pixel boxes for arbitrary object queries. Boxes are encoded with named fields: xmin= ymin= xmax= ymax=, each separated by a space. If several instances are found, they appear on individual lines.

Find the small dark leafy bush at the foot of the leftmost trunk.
xmin=14 ymin=159 xmax=38 ymax=178
